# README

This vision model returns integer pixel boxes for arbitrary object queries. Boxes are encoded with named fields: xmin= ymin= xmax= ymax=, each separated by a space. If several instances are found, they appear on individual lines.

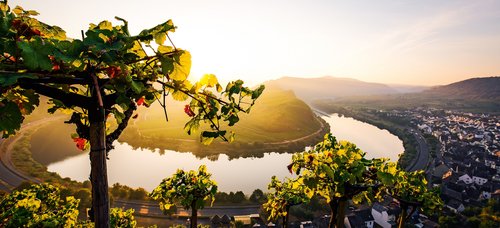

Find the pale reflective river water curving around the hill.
xmin=42 ymin=114 xmax=404 ymax=194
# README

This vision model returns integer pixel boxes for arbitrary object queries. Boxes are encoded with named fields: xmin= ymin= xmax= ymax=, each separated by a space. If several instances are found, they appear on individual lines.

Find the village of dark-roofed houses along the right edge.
xmin=412 ymin=110 xmax=500 ymax=213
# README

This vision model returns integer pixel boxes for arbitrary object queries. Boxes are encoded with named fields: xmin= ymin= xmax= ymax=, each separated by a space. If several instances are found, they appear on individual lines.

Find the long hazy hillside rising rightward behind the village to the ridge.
xmin=314 ymin=77 xmax=500 ymax=114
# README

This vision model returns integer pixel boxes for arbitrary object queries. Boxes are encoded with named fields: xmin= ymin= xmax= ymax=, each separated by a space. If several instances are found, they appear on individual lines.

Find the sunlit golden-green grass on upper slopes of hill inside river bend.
xmin=126 ymin=88 xmax=320 ymax=143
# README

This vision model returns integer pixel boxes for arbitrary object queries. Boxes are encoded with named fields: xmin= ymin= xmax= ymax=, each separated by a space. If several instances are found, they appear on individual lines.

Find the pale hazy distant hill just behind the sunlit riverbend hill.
xmin=265 ymin=76 xmax=398 ymax=102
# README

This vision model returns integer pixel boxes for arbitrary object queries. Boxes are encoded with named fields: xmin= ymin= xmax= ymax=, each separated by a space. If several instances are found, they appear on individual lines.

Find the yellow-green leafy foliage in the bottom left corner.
xmin=0 ymin=184 xmax=79 ymax=227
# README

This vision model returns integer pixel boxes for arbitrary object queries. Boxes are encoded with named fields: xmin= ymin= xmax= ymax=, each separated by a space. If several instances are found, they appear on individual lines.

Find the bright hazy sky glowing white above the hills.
xmin=9 ymin=0 xmax=500 ymax=85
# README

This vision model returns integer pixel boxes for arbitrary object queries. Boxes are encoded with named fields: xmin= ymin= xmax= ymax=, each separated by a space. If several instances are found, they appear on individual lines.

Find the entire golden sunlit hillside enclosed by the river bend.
xmin=119 ymin=86 xmax=329 ymax=157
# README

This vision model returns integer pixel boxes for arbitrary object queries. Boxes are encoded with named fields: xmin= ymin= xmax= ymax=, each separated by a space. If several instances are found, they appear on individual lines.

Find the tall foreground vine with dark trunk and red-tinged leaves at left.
xmin=0 ymin=0 xmax=264 ymax=227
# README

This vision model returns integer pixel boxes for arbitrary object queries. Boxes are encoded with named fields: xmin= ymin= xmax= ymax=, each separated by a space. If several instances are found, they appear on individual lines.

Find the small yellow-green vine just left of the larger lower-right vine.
xmin=262 ymin=176 xmax=314 ymax=227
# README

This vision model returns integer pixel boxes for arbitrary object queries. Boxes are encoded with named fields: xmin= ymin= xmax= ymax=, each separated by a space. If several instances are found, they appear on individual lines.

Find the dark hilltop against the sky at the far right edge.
xmin=423 ymin=77 xmax=500 ymax=100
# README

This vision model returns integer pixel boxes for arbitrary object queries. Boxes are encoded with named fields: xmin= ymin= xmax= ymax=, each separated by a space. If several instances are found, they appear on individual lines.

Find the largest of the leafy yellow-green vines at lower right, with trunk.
xmin=288 ymin=133 xmax=385 ymax=227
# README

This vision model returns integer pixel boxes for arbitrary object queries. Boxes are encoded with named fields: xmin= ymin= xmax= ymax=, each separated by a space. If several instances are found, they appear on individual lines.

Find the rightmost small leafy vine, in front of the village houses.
xmin=377 ymin=162 xmax=443 ymax=227
